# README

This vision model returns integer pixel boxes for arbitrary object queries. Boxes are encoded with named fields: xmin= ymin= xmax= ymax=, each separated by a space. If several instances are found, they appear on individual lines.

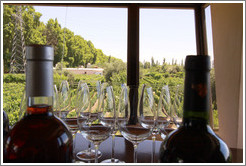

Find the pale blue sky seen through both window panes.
xmin=35 ymin=6 xmax=213 ymax=63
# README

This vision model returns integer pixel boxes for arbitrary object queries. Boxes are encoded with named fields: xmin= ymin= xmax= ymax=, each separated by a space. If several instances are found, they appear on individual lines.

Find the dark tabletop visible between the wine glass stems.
xmin=74 ymin=133 xmax=243 ymax=163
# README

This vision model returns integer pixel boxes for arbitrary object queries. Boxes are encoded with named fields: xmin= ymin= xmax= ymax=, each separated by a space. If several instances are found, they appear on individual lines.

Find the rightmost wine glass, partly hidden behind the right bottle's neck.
xmin=172 ymin=85 xmax=184 ymax=127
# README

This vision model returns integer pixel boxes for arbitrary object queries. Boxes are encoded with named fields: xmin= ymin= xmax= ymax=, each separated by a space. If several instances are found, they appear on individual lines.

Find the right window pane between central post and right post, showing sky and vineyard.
xmin=140 ymin=9 xmax=196 ymax=108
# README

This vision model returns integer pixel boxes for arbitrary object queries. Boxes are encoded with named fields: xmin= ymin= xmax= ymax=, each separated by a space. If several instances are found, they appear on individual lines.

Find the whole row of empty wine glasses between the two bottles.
xmin=19 ymin=81 xmax=183 ymax=162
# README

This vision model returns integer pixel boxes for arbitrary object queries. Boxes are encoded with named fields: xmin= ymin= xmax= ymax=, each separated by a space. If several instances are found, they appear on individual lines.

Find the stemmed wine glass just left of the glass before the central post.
xmin=100 ymin=83 xmax=122 ymax=163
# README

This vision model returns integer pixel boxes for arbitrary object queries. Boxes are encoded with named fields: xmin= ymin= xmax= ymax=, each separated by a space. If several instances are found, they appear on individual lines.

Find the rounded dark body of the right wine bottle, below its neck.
xmin=160 ymin=126 xmax=231 ymax=163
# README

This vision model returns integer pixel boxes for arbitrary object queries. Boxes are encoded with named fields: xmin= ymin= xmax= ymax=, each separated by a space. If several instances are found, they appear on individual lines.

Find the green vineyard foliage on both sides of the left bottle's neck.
xmin=3 ymin=73 xmax=104 ymax=126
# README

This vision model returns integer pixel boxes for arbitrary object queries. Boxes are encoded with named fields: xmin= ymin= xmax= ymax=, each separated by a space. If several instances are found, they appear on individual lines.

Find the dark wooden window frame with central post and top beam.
xmin=4 ymin=2 xmax=210 ymax=126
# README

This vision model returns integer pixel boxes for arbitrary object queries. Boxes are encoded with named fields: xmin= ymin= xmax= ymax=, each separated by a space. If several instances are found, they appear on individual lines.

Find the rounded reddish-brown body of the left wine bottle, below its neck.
xmin=4 ymin=115 xmax=73 ymax=162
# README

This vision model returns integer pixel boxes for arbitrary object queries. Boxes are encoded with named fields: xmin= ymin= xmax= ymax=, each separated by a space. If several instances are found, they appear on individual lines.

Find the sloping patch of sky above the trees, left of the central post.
xmin=35 ymin=6 xmax=127 ymax=62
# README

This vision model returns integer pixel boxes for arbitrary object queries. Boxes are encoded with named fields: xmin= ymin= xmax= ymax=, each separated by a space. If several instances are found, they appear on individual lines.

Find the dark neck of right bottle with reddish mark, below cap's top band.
xmin=183 ymin=70 xmax=210 ymax=126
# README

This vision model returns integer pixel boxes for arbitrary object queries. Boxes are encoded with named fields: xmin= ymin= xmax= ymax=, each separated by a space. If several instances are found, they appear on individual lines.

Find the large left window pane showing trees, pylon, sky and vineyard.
xmin=3 ymin=5 xmax=127 ymax=125
